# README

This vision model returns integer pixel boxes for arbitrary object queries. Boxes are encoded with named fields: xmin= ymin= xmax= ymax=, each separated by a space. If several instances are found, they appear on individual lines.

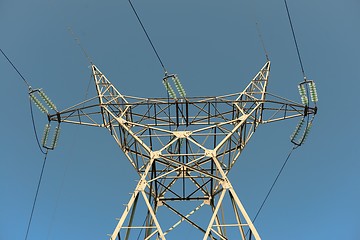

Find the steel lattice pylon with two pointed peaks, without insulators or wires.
xmin=49 ymin=62 xmax=316 ymax=240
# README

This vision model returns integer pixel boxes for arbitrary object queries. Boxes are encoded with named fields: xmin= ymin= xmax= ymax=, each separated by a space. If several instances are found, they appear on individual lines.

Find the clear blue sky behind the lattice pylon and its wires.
xmin=0 ymin=0 xmax=360 ymax=240
